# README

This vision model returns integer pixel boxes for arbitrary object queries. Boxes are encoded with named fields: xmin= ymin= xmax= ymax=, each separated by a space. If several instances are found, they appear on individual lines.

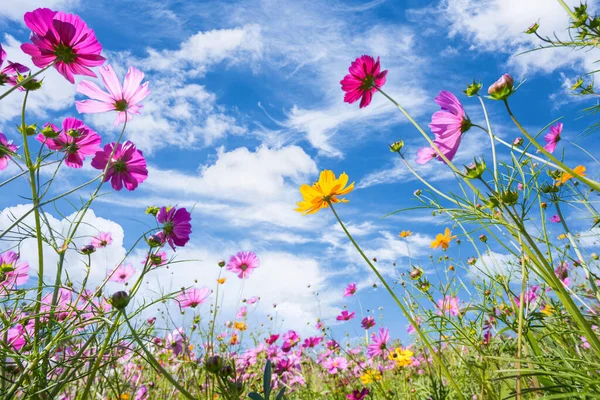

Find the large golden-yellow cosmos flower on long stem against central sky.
xmin=296 ymin=170 xmax=354 ymax=214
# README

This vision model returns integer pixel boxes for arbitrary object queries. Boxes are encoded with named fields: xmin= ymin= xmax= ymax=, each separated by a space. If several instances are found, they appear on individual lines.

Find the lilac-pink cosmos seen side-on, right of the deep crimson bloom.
xmin=417 ymin=90 xmax=472 ymax=164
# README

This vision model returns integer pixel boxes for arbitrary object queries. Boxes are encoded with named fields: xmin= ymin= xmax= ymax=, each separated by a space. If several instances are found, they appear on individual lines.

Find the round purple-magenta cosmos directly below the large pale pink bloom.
xmin=92 ymin=140 xmax=148 ymax=191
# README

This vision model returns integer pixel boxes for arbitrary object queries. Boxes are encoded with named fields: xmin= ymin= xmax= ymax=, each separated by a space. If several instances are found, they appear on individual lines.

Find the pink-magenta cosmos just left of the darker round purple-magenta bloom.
xmin=36 ymin=118 xmax=102 ymax=169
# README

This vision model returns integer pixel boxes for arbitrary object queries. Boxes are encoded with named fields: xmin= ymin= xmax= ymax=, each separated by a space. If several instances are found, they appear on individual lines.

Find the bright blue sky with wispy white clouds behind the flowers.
xmin=0 ymin=0 xmax=596 ymax=342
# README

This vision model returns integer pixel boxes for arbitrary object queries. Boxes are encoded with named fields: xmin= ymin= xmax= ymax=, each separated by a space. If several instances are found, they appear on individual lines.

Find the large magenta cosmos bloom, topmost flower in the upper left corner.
xmin=21 ymin=8 xmax=105 ymax=83
